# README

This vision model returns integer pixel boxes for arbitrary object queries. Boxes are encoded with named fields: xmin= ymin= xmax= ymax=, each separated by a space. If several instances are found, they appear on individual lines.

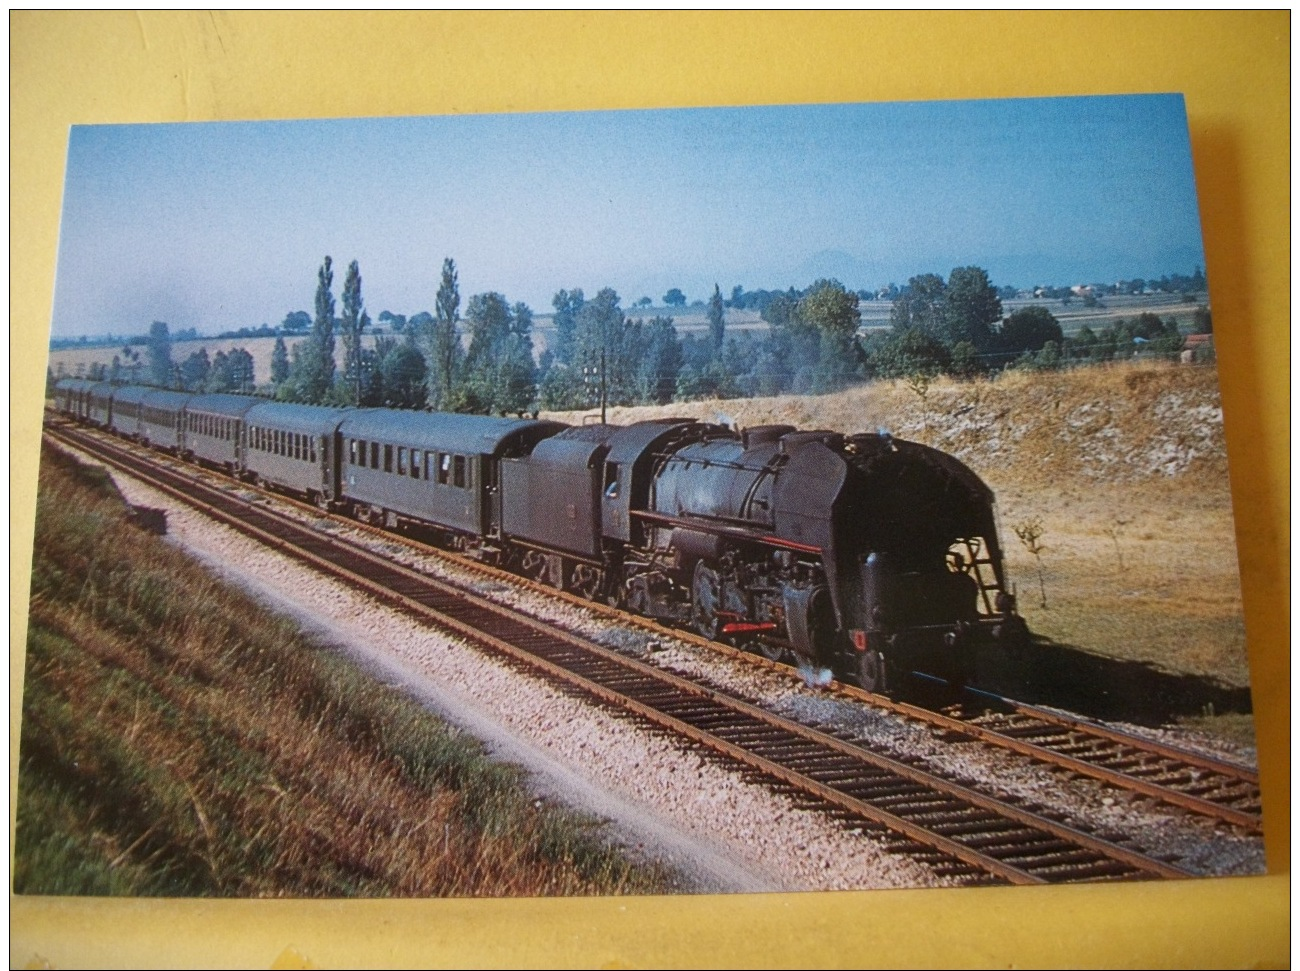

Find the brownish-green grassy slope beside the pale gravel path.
xmin=14 ymin=450 xmax=666 ymax=897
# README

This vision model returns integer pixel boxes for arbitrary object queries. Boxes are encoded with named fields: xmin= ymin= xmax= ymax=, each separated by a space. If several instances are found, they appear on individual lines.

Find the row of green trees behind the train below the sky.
xmin=73 ymin=256 xmax=1210 ymax=415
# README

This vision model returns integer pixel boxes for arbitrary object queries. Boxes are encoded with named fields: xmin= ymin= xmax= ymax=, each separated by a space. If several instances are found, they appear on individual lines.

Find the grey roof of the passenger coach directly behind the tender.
xmin=339 ymin=408 xmax=566 ymax=455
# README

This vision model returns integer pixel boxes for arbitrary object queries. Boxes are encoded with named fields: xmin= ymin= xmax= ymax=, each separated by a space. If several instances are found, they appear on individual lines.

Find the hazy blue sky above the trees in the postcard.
xmin=53 ymin=95 xmax=1204 ymax=337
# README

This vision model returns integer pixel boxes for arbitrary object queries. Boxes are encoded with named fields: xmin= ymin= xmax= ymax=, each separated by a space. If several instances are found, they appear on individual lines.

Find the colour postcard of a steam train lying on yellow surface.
xmin=14 ymin=95 xmax=1264 ymax=897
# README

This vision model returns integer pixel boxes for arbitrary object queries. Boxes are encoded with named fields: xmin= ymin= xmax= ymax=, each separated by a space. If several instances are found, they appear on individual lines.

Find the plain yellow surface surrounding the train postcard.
xmin=10 ymin=10 xmax=1291 ymax=967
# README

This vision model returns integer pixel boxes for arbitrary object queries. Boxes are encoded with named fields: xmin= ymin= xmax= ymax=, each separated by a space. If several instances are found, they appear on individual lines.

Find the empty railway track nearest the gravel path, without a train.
xmin=45 ymin=418 xmax=1253 ymax=883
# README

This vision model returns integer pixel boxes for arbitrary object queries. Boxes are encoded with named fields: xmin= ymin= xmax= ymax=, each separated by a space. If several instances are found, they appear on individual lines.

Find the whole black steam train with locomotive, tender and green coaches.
xmin=55 ymin=380 xmax=1024 ymax=690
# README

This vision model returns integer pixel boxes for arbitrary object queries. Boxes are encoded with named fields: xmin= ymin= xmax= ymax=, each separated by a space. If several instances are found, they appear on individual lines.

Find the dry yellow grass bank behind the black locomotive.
xmin=551 ymin=363 xmax=1249 ymax=717
